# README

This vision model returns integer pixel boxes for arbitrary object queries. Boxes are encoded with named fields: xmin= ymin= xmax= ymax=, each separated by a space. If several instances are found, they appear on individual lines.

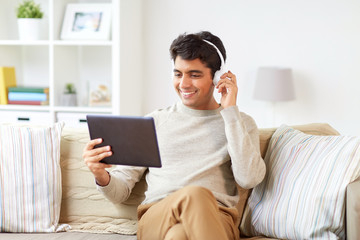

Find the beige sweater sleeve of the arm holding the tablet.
xmin=97 ymin=165 xmax=147 ymax=203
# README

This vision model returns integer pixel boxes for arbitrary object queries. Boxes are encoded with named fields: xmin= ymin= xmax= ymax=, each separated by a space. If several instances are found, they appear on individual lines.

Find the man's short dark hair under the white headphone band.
xmin=169 ymin=31 xmax=226 ymax=76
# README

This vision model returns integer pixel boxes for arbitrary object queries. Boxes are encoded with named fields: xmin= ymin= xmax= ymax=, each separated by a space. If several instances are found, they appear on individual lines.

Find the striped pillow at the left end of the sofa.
xmin=0 ymin=123 xmax=68 ymax=232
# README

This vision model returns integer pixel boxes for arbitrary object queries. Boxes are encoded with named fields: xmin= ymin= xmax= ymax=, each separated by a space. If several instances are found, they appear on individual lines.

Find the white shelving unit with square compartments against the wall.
xmin=0 ymin=0 xmax=121 ymax=127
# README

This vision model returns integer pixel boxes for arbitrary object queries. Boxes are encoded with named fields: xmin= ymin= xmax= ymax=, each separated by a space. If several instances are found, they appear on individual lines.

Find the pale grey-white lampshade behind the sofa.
xmin=254 ymin=67 xmax=295 ymax=102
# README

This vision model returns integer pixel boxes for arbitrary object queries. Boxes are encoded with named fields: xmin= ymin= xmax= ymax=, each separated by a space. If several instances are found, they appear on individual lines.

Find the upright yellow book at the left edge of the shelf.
xmin=0 ymin=67 xmax=16 ymax=104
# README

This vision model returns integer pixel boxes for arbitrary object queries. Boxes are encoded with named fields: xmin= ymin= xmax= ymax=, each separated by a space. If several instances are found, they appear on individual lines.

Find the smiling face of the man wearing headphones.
xmin=173 ymin=56 xmax=219 ymax=110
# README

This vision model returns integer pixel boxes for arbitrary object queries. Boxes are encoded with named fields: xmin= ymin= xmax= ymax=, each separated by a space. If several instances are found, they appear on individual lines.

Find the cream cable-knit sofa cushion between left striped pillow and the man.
xmin=60 ymin=126 xmax=146 ymax=234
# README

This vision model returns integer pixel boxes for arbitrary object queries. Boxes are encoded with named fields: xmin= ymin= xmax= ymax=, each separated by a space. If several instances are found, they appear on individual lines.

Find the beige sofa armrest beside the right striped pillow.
xmin=346 ymin=178 xmax=360 ymax=240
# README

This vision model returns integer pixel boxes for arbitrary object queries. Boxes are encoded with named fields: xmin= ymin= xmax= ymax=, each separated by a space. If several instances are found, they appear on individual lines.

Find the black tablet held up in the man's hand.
xmin=86 ymin=115 xmax=161 ymax=167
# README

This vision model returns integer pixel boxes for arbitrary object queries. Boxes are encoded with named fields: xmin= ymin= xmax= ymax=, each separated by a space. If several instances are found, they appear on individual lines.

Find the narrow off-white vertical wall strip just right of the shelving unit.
xmin=118 ymin=0 xmax=145 ymax=115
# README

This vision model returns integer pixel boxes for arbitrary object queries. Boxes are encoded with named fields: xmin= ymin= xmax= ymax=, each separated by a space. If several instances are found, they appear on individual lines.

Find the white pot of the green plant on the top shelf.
xmin=18 ymin=18 xmax=41 ymax=41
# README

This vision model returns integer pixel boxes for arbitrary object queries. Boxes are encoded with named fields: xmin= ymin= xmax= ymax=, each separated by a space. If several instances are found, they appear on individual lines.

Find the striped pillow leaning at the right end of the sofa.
xmin=241 ymin=125 xmax=360 ymax=239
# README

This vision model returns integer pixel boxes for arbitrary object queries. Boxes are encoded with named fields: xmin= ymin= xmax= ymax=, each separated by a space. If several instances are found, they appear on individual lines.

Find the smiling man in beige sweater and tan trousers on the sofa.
xmin=83 ymin=32 xmax=265 ymax=240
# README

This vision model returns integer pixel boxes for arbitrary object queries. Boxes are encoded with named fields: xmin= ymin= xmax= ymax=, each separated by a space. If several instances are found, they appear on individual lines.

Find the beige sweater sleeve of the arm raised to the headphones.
xmin=221 ymin=106 xmax=266 ymax=189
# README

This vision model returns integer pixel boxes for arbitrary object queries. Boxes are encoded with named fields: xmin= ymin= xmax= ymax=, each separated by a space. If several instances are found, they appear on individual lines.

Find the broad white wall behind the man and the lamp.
xmin=142 ymin=0 xmax=360 ymax=135
